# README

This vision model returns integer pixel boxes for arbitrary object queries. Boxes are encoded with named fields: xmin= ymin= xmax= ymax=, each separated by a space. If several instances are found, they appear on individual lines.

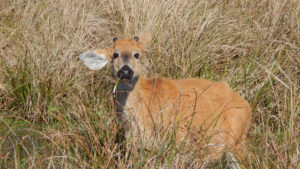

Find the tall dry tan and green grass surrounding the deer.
xmin=0 ymin=0 xmax=300 ymax=168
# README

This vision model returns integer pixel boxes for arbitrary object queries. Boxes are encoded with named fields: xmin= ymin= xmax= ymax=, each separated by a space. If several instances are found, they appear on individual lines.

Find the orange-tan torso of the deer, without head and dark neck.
xmin=129 ymin=78 xmax=251 ymax=149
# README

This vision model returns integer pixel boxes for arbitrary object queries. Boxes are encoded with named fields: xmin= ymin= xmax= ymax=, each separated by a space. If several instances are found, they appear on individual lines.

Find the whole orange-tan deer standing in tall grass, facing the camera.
xmin=79 ymin=31 xmax=252 ymax=168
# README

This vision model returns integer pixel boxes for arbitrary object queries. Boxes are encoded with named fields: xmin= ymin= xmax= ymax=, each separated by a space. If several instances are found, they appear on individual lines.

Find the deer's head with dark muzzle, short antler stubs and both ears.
xmin=79 ymin=32 xmax=151 ymax=82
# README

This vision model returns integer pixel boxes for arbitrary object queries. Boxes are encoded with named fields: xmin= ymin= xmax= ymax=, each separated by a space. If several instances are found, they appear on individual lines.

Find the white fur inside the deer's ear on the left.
xmin=79 ymin=51 xmax=108 ymax=70
